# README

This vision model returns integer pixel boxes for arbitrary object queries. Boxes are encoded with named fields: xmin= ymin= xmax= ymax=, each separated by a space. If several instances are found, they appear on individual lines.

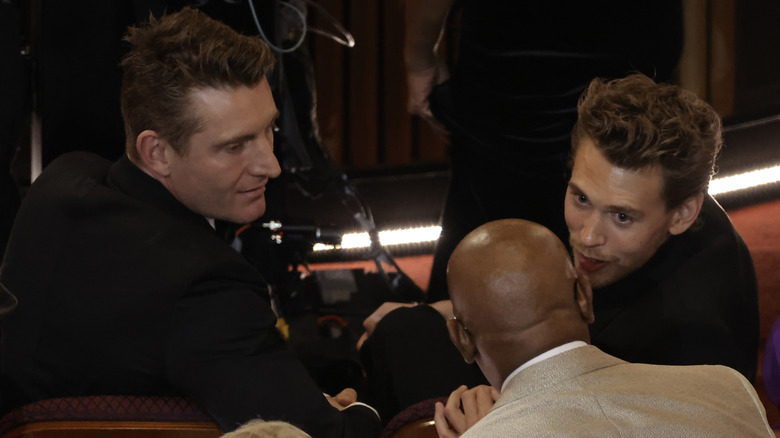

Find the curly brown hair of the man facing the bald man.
xmin=572 ymin=74 xmax=723 ymax=209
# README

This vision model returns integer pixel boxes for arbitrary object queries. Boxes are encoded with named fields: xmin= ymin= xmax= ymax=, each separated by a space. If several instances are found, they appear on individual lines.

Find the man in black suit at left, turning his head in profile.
xmin=0 ymin=8 xmax=381 ymax=437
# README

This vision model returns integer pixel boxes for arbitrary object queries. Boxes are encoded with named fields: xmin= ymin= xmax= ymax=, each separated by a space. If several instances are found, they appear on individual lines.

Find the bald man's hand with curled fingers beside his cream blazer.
xmin=433 ymin=385 xmax=499 ymax=438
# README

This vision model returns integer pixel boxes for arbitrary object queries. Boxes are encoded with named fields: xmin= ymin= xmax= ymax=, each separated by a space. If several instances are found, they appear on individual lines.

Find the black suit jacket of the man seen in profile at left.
xmin=0 ymin=153 xmax=380 ymax=437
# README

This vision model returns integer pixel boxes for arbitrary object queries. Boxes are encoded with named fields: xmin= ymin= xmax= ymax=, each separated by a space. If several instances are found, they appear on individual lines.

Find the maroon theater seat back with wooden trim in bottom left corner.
xmin=0 ymin=395 xmax=222 ymax=438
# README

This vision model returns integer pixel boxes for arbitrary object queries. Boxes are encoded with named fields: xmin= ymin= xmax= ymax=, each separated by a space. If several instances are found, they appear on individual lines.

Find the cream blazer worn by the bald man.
xmin=462 ymin=345 xmax=775 ymax=438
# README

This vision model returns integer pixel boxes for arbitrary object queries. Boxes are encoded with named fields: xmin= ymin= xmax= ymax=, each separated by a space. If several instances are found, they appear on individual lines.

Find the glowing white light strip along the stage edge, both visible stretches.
xmin=314 ymin=165 xmax=780 ymax=251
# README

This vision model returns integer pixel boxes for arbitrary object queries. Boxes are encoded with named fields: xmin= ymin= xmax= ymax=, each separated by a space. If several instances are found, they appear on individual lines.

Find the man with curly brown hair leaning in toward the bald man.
xmin=564 ymin=75 xmax=758 ymax=381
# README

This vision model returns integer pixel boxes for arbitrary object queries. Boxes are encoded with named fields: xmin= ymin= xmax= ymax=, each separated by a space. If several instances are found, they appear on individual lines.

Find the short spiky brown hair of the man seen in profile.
xmin=121 ymin=7 xmax=274 ymax=159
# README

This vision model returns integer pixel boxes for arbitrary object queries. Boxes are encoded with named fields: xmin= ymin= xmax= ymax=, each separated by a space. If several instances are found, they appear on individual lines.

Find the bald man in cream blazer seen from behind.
xmin=436 ymin=219 xmax=774 ymax=438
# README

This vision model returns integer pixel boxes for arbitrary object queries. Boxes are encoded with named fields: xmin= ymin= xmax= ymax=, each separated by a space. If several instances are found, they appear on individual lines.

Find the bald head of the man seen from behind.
xmin=447 ymin=219 xmax=592 ymax=388
